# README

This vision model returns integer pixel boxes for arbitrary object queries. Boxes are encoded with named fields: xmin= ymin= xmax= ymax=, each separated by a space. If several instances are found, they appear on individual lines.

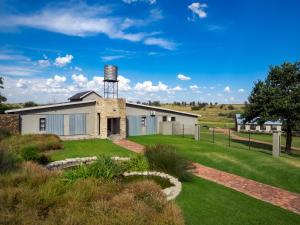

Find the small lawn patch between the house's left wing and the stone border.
xmin=51 ymin=139 xmax=135 ymax=161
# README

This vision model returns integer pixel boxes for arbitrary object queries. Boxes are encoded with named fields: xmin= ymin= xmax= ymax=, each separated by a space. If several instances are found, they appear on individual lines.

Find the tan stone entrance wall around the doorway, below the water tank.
xmin=94 ymin=98 xmax=126 ymax=138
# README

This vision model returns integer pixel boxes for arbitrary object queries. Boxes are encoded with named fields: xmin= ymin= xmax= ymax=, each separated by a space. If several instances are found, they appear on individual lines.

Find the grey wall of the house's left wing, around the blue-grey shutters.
xmin=21 ymin=103 xmax=96 ymax=136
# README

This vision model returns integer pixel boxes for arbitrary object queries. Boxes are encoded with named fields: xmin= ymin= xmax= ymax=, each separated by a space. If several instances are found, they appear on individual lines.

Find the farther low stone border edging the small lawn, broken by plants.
xmin=46 ymin=156 xmax=130 ymax=170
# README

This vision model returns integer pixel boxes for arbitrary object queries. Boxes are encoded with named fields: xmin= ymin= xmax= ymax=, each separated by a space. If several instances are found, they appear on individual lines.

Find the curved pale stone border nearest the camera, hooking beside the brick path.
xmin=123 ymin=171 xmax=182 ymax=201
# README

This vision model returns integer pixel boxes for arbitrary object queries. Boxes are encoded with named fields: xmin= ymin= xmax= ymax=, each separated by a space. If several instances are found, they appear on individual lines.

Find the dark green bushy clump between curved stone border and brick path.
xmin=145 ymin=144 xmax=192 ymax=181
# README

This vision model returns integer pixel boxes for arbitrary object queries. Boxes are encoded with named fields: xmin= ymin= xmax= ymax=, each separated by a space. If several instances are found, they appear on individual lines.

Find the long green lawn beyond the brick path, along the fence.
xmin=130 ymin=135 xmax=300 ymax=193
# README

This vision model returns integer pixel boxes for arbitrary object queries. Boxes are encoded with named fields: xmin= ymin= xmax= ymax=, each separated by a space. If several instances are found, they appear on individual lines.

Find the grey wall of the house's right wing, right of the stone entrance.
xmin=126 ymin=105 xmax=198 ymax=134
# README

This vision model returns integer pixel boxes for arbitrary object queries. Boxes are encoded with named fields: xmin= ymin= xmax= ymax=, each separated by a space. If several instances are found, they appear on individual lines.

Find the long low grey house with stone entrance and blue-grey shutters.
xmin=6 ymin=91 xmax=198 ymax=139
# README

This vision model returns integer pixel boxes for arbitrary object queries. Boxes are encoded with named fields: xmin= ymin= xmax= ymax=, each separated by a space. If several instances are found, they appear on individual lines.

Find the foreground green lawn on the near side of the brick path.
xmin=176 ymin=178 xmax=300 ymax=225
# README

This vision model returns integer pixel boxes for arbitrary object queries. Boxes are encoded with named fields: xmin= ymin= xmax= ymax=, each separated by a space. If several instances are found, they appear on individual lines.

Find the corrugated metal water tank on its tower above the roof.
xmin=103 ymin=65 xmax=118 ymax=98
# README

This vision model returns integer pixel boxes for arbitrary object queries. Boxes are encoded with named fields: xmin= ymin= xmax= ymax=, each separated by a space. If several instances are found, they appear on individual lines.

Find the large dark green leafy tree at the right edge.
xmin=244 ymin=62 xmax=300 ymax=153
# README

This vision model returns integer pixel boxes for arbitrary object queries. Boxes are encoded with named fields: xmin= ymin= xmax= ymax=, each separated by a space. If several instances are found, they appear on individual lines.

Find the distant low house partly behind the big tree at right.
xmin=235 ymin=114 xmax=282 ymax=133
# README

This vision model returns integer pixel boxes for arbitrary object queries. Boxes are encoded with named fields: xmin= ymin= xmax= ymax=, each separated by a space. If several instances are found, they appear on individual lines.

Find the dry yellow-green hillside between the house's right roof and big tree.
xmin=161 ymin=104 xmax=244 ymax=127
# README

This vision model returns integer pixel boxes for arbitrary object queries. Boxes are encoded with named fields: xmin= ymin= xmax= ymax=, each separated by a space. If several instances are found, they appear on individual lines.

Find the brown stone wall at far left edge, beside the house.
xmin=0 ymin=114 xmax=20 ymax=134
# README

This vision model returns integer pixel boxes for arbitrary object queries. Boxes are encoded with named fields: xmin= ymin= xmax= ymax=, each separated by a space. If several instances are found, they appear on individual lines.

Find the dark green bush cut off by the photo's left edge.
xmin=0 ymin=147 xmax=20 ymax=173
